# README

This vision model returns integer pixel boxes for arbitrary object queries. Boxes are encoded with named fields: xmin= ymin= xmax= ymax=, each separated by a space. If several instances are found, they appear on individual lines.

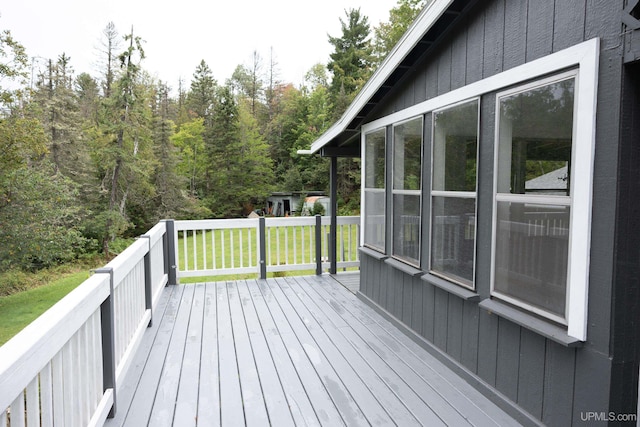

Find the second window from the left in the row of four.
xmin=392 ymin=117 xmax=422 ymax=266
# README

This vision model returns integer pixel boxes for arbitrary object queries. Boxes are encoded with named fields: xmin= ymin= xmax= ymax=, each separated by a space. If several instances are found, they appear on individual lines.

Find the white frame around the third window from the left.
xmin=427 ymin=96 xmax=481 ymax=291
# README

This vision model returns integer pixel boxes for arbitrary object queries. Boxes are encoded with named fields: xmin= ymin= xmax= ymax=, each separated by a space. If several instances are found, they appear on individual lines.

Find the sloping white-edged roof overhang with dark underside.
xmin=298 ymin=0 xmax=476 ymax=157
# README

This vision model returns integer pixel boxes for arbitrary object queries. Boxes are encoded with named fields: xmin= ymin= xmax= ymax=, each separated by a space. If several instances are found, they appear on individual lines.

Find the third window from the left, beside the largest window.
xmin=430 ymin=99 xmax=479 ymax=288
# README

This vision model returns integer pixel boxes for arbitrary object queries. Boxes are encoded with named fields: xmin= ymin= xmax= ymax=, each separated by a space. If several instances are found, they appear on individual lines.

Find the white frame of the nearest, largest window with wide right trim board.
xmin=491 ymin=65 xmax=598 ymax=341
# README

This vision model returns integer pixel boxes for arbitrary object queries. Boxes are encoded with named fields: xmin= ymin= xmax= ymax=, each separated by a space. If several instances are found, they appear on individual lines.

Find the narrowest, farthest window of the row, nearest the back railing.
xmin=363 ymin=128 xmax=386 ymax=252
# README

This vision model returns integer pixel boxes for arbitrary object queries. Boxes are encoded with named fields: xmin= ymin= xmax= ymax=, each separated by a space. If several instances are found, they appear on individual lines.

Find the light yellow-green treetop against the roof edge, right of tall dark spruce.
xmin=373 ymin=0 xmax=433 ymax=66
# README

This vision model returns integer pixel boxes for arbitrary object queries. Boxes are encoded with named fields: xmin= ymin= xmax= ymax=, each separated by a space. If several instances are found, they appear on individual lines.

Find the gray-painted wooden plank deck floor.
xmin=105 ymin=275 xmax=518 ymax=427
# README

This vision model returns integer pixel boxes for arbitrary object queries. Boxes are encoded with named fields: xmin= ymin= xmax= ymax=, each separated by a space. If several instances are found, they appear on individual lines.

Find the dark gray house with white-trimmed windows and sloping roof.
xmin=307 ymin=0 xmax=640 ymax=426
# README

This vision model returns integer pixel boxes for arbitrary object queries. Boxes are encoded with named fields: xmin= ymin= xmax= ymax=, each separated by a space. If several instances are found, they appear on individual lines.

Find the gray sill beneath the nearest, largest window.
xmin=478 ymin=299 xmax=582 ymax=347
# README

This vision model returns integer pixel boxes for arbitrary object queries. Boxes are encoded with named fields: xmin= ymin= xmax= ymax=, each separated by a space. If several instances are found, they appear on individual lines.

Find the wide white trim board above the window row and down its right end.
xmin=362 ymin=38 xmax=600 ymax=341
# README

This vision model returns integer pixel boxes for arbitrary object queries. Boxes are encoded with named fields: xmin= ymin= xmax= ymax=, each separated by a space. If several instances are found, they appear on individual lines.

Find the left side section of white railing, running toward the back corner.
xmin=0 ymin=222 xmax=168 ymax=427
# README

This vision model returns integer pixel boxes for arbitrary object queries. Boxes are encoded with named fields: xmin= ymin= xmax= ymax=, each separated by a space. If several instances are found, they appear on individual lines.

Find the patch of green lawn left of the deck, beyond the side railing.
xmin=0 ymin=271 xmax=89 ymax=345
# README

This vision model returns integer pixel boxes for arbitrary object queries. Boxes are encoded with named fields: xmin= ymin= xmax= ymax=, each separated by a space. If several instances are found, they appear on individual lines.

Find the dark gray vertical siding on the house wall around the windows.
xmin=361 ymin=0 xmax=640 ymax=426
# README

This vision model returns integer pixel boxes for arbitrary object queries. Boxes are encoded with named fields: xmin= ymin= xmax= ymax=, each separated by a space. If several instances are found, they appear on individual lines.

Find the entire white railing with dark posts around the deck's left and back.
xmin=0 ymin=217 xmax=360 ymax=427
